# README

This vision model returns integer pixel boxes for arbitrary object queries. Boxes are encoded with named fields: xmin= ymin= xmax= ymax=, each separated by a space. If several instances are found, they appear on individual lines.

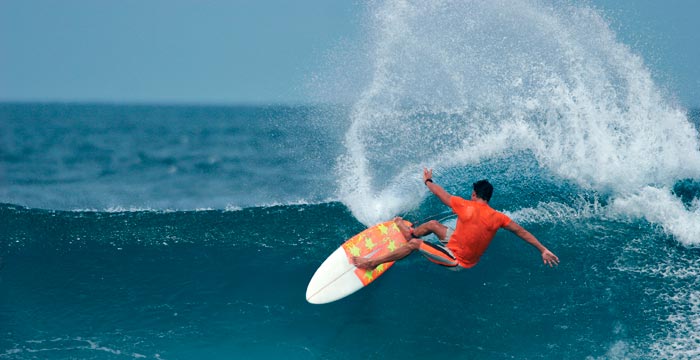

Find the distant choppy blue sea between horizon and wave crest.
xmin=0 ymin=104 xmax=339 ymax=210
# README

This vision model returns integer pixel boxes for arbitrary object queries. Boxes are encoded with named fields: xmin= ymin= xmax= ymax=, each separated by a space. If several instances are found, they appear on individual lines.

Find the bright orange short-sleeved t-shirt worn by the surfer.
xmin=447 ymin=196 xmax=511 ymax=268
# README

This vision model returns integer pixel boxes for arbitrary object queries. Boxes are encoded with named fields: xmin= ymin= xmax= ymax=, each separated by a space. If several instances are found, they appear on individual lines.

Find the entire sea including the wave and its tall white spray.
xmin=0 ymin=1 xmax=700 ymax=359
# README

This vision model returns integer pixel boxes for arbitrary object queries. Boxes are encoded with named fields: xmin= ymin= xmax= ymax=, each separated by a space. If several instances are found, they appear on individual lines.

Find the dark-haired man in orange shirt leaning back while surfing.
xmin=353 ymin=169 xmax=559 ymax=269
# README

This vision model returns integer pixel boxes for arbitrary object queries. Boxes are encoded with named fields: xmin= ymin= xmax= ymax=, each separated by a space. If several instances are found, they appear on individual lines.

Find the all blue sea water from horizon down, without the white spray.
xmin=0 ymin=104 xmax=700 ymax=359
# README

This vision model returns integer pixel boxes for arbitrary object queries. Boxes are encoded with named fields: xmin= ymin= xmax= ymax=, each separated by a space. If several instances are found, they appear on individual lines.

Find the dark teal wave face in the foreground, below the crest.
xmin=0 ymin=200 xmax=700 ymax=359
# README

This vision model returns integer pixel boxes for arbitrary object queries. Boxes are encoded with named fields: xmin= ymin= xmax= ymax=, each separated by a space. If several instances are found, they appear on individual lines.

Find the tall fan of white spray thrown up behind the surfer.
xmin=337 ymin=0 xmax=700 ymax=245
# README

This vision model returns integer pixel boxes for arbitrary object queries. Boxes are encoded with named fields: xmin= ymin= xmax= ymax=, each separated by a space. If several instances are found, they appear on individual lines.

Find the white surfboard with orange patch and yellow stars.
xmin=306 ymin=221 xmax=410 ymax=304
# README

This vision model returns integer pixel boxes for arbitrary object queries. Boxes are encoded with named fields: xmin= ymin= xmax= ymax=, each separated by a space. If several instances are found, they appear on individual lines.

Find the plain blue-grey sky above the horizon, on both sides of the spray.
xmin=0 ymin=0 xmax=700 ymax=107
